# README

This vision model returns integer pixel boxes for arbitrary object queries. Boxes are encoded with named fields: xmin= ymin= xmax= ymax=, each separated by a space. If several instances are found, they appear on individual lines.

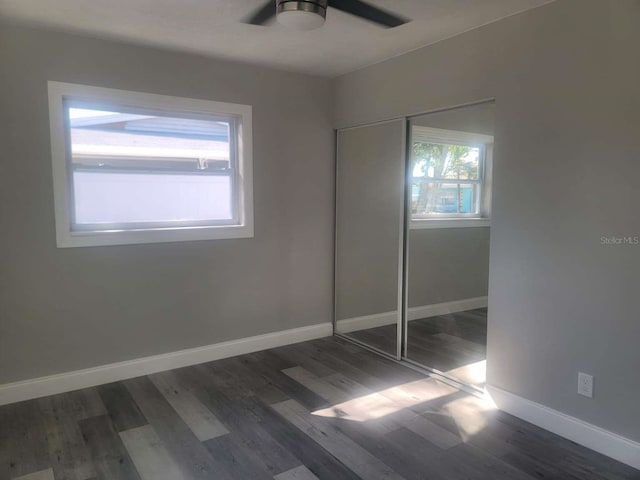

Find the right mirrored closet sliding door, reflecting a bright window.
xmin=403 ymin=103 xmax=494 ymax=387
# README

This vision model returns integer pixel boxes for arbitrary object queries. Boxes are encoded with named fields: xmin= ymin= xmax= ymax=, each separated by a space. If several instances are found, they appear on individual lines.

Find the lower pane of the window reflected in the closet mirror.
xmin=411 ymin=181 xmax=479 ymax=218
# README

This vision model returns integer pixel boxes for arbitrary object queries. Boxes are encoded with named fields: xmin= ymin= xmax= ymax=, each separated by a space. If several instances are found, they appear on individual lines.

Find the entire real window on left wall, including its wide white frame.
xmin=49 ymin=82 xmax=253 ymax=247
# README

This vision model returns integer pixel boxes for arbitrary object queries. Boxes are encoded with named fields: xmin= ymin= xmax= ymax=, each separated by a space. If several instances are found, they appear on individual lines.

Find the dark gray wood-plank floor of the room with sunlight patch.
xmin=0 ymin=338 xmax=640 ymax=480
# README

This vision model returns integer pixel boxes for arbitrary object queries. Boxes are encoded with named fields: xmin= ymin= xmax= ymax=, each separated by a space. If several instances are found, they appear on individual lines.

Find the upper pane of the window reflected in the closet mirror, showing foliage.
xmin=413 ymin=142 xmax=480 ymax=180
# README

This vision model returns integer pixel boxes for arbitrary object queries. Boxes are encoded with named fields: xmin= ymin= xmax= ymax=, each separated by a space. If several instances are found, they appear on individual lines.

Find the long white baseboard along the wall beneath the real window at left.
xmin=0 ymin=322 xmax=333 ymax=405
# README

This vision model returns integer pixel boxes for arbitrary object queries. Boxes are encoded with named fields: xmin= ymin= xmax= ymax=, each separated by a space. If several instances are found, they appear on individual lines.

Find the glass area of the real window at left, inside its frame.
xmin=67 ymin=106 xmax=235 ymax=226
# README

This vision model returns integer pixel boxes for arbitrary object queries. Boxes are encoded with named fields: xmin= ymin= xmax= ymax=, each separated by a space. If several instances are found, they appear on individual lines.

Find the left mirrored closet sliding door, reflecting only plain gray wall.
xmin=335 ymin=119 xmax=406 ymax=358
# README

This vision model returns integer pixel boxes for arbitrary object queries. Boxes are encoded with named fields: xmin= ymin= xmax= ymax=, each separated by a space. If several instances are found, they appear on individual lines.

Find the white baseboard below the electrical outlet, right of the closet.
xmin=487 ymin=386 xmax=640 ymax=469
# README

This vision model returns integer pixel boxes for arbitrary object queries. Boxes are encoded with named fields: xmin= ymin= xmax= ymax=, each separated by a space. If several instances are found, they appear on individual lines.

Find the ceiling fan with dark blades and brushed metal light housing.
xmin=244 ymin=0 xmax=409 ymax=30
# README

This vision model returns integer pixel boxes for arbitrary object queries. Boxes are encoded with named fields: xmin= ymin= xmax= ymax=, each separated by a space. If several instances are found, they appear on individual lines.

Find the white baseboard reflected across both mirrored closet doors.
xmin=337 ymin=297 xmax=488 ymax=333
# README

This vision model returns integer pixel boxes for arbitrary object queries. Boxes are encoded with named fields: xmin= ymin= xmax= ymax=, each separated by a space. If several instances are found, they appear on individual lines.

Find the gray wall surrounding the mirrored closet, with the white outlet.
xmin=335 ymin=0 xmax=640 ymax=441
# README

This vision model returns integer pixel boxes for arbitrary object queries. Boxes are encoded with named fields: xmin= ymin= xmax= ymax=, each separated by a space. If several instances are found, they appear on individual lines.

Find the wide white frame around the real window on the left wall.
xmin=48 ymin=81 xmax=253 ymax=248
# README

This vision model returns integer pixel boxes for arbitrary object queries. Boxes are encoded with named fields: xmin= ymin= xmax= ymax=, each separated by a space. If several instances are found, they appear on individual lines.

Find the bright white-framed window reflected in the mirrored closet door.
xmin=410 ymin=125 xmax=493 ymax=228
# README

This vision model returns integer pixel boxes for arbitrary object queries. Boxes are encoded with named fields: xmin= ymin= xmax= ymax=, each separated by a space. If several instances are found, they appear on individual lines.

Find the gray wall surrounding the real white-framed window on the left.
xmin=0 ymin=26 xmax=334 ymax=384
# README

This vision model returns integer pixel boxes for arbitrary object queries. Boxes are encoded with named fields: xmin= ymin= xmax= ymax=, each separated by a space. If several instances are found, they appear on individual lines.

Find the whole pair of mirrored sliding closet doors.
xmin=335 ymin=102 xmax=494 ymax=388
